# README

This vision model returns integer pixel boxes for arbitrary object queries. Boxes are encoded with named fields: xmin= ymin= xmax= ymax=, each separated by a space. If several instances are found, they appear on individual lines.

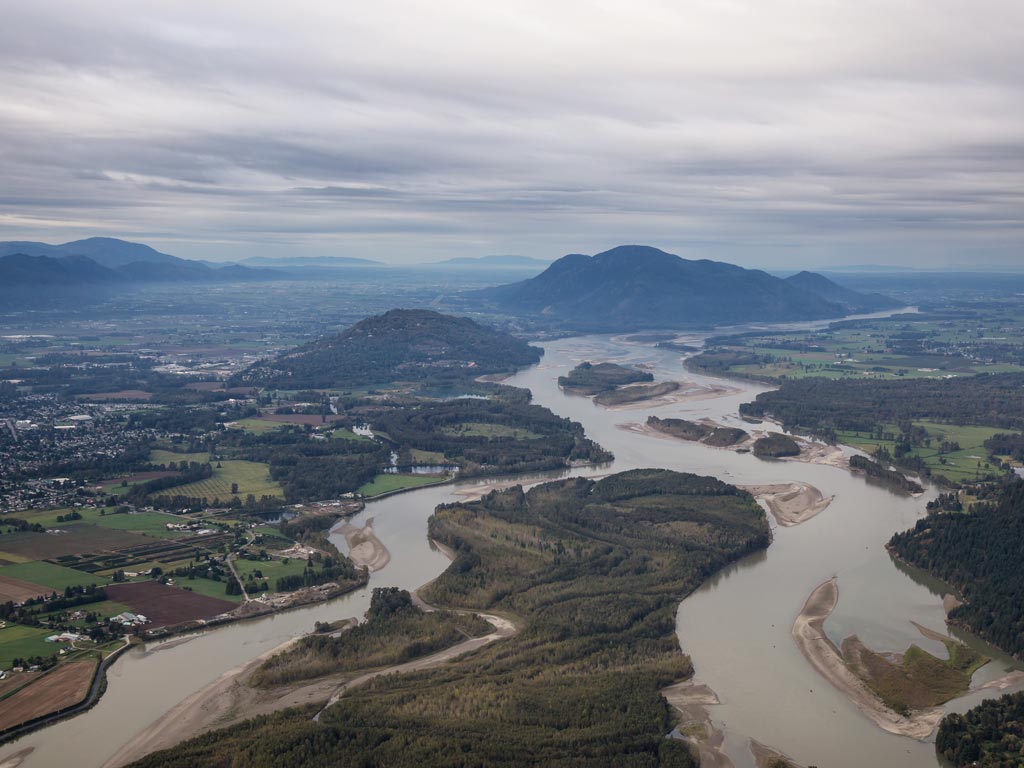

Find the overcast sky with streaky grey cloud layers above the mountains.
xmin=0 ymin=0 xmax=1024 ymax=267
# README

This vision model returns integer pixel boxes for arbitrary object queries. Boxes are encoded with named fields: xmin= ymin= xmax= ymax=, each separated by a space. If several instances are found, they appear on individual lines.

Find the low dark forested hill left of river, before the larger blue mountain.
xmin=234 ymin=309 xmax=542 ymax=389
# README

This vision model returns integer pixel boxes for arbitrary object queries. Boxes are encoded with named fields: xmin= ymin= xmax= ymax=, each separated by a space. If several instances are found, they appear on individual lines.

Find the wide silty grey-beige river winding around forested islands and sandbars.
xmin=0 ymin=324 xmax=1018 ymax=768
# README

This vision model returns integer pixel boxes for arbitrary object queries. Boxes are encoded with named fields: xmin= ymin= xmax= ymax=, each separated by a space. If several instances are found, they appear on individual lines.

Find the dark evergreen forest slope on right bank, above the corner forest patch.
xmin=889 ymin=480 xmax=1024 ymax=656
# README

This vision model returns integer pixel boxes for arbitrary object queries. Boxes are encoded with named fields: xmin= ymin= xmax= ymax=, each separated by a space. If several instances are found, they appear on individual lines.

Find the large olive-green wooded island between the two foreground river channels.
xmin=130 ymin=470 xmax=770 ymax=768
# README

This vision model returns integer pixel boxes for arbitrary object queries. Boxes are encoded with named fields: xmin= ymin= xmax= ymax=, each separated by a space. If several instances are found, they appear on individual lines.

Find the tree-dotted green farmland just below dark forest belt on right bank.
xmin=837 ymin=421 xmax=1007 ymax=482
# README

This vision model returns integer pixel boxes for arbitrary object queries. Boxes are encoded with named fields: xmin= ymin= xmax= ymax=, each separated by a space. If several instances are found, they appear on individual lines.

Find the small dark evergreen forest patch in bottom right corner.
xmin=935 ymin=692 xmax=1024 ymax=768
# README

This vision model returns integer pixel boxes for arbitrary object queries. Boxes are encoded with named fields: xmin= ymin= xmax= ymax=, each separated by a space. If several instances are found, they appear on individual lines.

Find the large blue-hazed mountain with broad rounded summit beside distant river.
xmin=470 ymin=246 xmax=892 ymax=332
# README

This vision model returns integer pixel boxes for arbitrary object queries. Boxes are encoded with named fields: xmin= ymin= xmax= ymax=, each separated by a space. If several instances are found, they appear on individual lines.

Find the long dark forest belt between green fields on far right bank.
xmin=739 ymin=374 xmax=1024 ymax=431
